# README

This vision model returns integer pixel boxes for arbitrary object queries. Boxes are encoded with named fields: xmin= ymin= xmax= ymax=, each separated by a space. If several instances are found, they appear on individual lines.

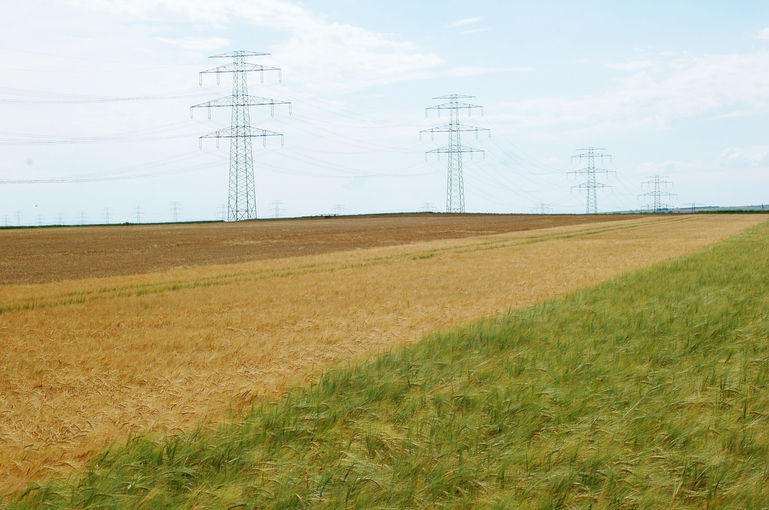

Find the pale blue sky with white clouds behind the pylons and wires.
xmin=0 ymin=0 xmax=769 ymax=226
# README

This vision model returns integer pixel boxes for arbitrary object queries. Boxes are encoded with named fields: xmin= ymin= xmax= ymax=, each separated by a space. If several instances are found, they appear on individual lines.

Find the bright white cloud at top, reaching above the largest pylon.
xmin=75 ymin=0 xmax=446 ymax=90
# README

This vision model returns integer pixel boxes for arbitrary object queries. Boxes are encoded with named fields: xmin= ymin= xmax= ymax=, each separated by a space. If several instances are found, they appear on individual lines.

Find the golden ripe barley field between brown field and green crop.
xmin=0 ymin=215 xmax=765 ymax=490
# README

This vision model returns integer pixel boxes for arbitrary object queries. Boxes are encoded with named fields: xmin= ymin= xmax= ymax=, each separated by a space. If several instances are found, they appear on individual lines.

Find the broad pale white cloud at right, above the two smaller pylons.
xmin=498 ymin=52 xmax=769 ymax=131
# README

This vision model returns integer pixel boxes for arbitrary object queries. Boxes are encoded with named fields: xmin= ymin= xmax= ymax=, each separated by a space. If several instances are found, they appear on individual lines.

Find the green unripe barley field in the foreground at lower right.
xmin=9 ymin=218 xmax=769 ymax=509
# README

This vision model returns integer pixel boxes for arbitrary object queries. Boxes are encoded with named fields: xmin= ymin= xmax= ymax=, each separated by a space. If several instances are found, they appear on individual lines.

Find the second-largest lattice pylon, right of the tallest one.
xmin=420 ymin=94 xmax=490 ymax=213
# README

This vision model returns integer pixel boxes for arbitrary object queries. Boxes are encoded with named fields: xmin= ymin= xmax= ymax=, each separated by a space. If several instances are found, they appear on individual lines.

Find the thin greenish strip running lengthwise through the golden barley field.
xmin=0 ymin=213 xmax=680 ymax=314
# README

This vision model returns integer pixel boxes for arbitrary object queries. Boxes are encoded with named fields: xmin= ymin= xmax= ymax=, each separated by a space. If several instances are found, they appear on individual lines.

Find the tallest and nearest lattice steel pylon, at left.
xmin=191 ymin=50 xmax=291 ymax=221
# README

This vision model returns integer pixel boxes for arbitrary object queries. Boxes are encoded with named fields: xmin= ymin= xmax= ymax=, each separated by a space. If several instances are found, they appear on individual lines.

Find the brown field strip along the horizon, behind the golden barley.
xmin=0 ymin=214 xmax=626 ymax=284
